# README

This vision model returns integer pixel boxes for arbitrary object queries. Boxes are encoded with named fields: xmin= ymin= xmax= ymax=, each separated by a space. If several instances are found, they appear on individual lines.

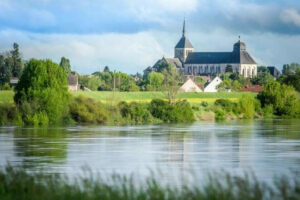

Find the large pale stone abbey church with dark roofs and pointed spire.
xmin=154 ymin=21 xmax=257 ymax=77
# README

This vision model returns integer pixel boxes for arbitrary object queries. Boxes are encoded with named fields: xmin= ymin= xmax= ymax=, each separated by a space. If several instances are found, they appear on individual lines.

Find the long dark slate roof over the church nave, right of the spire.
xmin=185 ymin=51 xmax=256 ymax=64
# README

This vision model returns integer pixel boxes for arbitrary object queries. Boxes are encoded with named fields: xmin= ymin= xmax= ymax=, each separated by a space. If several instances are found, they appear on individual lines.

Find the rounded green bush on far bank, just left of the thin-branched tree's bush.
xmin=118 ymin=101 xmax=153 ymax=124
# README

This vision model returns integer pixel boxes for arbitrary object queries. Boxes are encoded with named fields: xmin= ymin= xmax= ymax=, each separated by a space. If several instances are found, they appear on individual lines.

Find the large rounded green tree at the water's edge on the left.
xmin=14 ymin=59 xmax=69 ymax=125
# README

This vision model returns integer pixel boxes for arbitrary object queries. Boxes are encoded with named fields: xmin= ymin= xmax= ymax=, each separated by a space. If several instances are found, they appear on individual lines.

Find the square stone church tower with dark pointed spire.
xmin=174 ymin=20 xmax=194 ymax=63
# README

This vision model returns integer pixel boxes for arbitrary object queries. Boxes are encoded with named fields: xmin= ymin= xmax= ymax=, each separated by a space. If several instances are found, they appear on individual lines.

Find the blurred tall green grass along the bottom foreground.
xmin=0 ymin=167 xmax=300 ymax=200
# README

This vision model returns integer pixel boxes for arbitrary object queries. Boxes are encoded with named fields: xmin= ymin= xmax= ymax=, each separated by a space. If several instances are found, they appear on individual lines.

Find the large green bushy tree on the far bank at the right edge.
xmin=257 ymin=81 xmax=299 ymax=117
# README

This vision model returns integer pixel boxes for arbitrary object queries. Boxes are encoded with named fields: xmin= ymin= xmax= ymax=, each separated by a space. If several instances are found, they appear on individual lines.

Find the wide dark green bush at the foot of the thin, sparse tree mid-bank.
xmin=149 ymin=99 xmax=194 ymax=123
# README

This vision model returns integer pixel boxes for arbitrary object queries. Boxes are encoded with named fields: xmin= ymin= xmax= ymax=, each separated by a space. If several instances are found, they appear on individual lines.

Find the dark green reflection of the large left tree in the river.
xmin=14 ymin=128 xmax=67 ymax=167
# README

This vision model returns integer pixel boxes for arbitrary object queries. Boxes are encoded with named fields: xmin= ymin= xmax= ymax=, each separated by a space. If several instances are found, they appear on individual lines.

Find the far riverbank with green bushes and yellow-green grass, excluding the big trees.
xmin=0 ymin=91 xmax=298 ymax=126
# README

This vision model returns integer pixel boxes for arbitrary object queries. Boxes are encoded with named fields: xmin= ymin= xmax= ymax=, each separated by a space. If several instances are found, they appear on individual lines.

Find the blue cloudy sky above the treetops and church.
xmin=0 ymin=0 xmax=300 ymax=73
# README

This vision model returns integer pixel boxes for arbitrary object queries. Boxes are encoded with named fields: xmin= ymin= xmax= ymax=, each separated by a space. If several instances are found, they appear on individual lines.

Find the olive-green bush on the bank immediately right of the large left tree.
xmin=69 ymin=96 xmax=108 ymax=124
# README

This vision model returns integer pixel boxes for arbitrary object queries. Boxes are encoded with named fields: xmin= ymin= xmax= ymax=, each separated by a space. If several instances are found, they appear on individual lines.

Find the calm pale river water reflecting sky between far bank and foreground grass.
xmin=0 ymin=120 xmax=300 ymax=180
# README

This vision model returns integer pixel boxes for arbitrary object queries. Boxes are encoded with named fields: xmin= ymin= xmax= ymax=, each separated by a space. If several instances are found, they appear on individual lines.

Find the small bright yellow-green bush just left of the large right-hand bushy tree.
xmin=237 ymin=95 xmax=257 ymax=119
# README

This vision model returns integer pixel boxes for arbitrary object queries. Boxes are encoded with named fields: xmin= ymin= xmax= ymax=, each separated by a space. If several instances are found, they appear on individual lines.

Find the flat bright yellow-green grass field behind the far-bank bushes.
xmin=0 ymin=91 xmax=256 ymax=103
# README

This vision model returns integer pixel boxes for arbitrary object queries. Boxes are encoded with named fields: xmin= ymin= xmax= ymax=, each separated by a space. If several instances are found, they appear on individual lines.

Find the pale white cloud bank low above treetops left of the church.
xmin=0 ymin=30 xmax=164 ymax=73
